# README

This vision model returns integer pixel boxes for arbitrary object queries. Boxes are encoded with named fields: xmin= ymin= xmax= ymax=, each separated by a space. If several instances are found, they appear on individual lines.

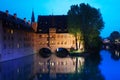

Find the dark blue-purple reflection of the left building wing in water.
xmin=0 ymin=56 xmax=33 ymax=80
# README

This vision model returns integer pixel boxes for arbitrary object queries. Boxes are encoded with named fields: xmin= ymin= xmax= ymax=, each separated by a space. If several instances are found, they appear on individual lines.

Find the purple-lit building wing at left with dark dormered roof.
xmin=0 ymin=11 xmax=34 ymax=62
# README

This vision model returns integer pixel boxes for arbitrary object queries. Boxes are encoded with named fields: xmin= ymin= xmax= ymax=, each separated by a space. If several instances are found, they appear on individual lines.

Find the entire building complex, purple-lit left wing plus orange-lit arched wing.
xmin=0 ymin=10 xmax=83 ymax=62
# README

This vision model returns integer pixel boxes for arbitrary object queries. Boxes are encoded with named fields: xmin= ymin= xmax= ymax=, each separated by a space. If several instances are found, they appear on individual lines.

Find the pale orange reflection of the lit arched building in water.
xmin=34 ymin=54 xmax=84 ymax=80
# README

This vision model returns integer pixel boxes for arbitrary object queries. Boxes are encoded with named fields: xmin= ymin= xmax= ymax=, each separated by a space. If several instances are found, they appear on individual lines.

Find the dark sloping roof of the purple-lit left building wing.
xmin=0 ymin=11 xmax=33 ymax=31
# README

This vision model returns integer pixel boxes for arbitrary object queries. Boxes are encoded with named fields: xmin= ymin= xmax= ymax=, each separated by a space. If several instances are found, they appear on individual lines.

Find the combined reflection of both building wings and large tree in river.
xmin=0 ymin=54 xmax=104 ymax=80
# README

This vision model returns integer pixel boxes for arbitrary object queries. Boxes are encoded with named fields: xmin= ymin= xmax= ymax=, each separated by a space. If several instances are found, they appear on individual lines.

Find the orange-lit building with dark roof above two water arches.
xmin=35 ymin=15 xmax=75 ymax=52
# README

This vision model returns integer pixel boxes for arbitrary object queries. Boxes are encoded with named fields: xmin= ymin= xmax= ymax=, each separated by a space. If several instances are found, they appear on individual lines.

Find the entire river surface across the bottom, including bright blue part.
xmin=0 ymin=50 xmax=120 ymax=80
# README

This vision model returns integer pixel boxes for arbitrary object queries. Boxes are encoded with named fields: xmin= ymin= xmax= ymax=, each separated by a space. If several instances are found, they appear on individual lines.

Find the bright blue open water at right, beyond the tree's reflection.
xmin=99 ymin=50 xmax=120 ymax=80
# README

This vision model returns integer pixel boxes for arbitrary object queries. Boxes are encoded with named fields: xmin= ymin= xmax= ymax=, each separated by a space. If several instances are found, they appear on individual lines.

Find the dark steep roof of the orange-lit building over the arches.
xmin=37 ymin=15 xmax=68 ymax=33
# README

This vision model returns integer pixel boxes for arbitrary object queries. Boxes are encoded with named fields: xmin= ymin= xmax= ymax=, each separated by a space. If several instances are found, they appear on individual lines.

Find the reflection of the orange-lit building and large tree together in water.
xmin=32 ymin=54 xmax=104 ymax=80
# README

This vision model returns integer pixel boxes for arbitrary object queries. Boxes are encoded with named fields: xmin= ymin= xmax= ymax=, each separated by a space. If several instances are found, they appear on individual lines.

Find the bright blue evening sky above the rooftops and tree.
xmin=0 ymin=0 xmax=120 ymax=37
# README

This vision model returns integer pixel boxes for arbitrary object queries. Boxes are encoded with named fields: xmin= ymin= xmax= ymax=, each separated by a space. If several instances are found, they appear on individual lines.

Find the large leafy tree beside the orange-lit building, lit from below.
xmin=68 ymin=3 xmax=104 ymax=51
